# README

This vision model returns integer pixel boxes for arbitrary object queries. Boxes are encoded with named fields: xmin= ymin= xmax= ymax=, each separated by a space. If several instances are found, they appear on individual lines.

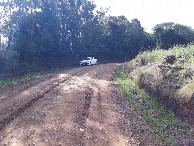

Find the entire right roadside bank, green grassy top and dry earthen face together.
xmin=125 ymin=45 xmax=194 ymax=126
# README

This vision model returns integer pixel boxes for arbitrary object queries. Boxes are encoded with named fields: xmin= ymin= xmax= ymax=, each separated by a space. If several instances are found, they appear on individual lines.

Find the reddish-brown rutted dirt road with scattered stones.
xmin=0 ymin=64 xmax=163 ymax=146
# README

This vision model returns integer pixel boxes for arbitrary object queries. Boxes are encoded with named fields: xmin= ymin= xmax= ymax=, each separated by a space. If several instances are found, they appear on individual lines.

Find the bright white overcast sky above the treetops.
xmin=93 ymin=0 xmax=194 ymax=32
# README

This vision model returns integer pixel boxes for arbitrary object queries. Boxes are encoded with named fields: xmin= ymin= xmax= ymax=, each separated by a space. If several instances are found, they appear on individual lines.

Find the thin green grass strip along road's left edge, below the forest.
xmin=0 ymin=67 xmax=72 ymax=86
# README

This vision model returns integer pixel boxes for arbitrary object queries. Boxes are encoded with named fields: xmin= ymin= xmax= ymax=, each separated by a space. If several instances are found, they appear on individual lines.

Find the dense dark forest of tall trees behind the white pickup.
xmin=0 ymin=0 xmax=194 ymax=73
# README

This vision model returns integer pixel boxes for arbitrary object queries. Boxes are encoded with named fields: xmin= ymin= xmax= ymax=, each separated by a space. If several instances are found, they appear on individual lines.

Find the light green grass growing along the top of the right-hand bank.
xmin=135 ymin=44 xmax=194 ymax=65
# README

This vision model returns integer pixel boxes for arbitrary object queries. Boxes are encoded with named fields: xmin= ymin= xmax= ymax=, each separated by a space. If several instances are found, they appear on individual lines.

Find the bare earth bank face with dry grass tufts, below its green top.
xmin=125 ymin=60 xmax=194 ymax=126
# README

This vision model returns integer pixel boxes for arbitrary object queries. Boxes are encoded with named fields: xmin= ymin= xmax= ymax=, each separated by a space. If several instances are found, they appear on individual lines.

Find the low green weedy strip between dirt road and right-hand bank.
xmin=117 ymin=67 xmax=192 ymax=145
